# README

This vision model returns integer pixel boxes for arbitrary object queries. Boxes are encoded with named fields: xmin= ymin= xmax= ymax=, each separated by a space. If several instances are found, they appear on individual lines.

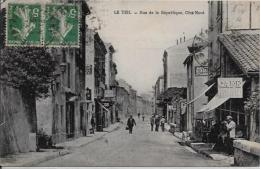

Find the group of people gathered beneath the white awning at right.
xmin=209 ymin=116 xmax=236 ymax=155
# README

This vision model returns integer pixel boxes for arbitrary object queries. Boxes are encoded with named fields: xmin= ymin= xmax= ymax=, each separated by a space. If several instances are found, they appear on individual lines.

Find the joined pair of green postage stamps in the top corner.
xmin=6 ymin=3 xmax=80 ymax=47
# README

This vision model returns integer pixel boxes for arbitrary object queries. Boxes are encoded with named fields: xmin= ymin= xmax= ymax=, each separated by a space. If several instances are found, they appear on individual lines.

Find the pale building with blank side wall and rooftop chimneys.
xmin=162 ymin=36 xmax=193 ymax=127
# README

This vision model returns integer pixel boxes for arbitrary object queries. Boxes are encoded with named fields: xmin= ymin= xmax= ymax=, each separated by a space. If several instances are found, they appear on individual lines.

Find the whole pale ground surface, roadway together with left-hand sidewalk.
xmin=0 ymin=119 xmax=231 ymax=167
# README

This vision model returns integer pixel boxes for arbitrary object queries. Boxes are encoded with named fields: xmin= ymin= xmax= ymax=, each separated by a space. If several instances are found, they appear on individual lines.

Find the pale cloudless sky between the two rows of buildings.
xmin=87 ymin=0 xmax=208 ymax=93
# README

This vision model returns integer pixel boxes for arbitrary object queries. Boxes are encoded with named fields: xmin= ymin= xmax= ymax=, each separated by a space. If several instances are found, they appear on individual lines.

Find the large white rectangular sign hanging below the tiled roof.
xmin=218 ymin=78 xmax=243 ymax=98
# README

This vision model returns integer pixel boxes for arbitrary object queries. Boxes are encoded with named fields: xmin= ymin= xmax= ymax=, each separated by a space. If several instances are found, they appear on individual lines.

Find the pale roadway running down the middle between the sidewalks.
xmin=38 ymin=118 xmax=230 ymax=167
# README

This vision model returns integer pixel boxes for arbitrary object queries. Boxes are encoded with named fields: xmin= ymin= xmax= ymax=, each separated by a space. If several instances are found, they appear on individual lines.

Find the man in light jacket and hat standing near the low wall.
xmin=226 ymin=116 xmax=236 ymax=155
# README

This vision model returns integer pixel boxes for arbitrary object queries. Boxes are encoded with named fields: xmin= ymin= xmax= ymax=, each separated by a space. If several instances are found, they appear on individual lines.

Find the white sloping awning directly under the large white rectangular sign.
xmin=198 ymin=95 xmax=229 ymax=112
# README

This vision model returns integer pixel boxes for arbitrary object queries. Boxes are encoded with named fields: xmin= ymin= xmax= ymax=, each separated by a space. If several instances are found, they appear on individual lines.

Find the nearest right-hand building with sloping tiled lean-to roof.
xmin=206 ymin=1 xmax=260 ymax=140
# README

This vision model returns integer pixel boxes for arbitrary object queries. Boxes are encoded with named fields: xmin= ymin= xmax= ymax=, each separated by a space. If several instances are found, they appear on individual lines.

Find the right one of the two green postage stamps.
xmin=44 ymin=4 xmax=80 ymax=47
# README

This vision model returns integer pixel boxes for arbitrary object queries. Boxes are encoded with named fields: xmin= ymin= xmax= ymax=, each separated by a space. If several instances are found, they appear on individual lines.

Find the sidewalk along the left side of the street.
xmin=0 ymin=123 xmax=122 ymax=167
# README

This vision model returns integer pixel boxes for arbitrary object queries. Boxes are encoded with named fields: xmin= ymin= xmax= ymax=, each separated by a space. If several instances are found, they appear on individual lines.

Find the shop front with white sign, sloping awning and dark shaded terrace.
xmin=197 ymin=77 xmax=248 ymax=145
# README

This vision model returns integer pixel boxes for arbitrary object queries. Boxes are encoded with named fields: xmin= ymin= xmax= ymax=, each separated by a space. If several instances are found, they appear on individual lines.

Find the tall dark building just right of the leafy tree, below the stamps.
xmin=36 ymin=1 xmax=90 ymax=144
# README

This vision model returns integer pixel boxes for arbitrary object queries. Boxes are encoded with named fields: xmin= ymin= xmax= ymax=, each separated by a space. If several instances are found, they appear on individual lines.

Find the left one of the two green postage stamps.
xmin=6 ymin=3 xmax=42 ymax=46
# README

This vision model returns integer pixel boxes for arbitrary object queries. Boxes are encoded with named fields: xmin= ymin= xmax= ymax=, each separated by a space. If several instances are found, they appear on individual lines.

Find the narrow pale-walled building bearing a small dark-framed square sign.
xmin=183 ymin=31 xmax=209 ymax=138
